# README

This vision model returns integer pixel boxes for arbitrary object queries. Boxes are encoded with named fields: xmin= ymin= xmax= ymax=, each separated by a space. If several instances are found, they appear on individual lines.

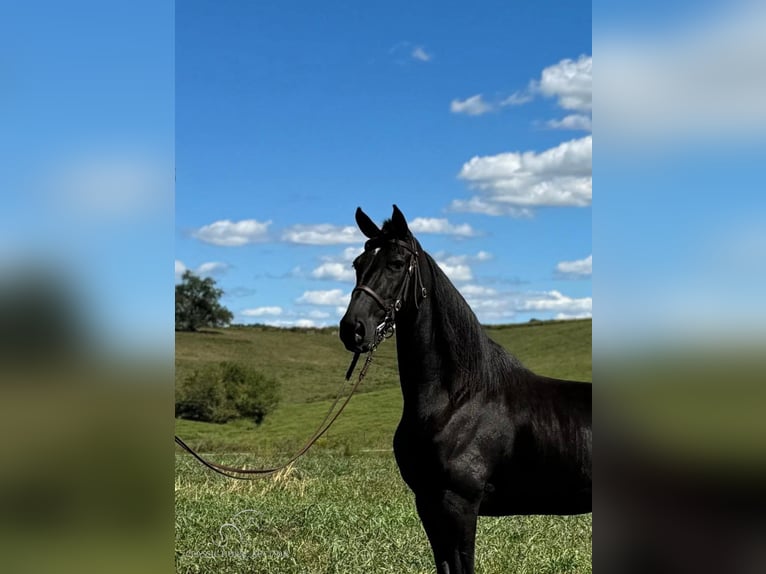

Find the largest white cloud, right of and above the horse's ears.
xmin=451 ymin=136 xmax=593 ymax=215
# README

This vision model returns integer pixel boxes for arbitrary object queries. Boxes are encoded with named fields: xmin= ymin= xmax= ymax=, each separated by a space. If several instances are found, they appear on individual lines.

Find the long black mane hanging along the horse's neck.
xmin=381 ymin=219 xmax=529 ymax=395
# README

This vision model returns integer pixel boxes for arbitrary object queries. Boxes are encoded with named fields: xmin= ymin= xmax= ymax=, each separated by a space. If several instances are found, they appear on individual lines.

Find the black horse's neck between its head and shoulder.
xmin=396 ymin=253 xmax=485 ymax=404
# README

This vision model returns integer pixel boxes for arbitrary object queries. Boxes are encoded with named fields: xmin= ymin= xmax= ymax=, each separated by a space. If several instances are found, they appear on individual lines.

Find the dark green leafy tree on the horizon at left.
xmin=176 ymin=270 xmax=234 ymax=331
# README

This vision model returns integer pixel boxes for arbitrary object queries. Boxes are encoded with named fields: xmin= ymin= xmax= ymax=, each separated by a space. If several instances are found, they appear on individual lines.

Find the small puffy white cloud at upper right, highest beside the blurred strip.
xmin=534 ymin=55 xmax=593 ymax=112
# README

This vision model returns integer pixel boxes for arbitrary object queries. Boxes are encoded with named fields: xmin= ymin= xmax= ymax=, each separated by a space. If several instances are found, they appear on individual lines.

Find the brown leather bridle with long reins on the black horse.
xmin=175 ymin=238 xmax=427 ymax=480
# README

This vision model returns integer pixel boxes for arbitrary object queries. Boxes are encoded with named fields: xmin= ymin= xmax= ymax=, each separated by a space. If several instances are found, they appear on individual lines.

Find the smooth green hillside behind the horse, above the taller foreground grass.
xmin=176 ymin=320 xmax=592 ymax=457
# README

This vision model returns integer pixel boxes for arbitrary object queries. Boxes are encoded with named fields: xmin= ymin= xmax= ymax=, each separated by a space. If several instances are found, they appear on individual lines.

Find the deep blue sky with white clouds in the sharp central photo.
xmin=175 ymin=1 xmax=592 ymax=325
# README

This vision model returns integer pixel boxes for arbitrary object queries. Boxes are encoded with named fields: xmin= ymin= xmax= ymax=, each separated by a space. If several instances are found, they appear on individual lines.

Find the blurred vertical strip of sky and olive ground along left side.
xmin=0 ymin=0 xmax=174 ymax=573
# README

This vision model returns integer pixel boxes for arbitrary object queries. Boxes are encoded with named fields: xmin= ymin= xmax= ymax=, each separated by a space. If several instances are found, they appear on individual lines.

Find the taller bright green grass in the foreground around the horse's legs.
xmin=176 ymin=452 xmax=592 ymax=574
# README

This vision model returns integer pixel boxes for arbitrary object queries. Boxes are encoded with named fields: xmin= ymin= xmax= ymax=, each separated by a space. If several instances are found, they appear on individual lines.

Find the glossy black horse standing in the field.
xmin=340 ymin=206 xmax=592 ymax=574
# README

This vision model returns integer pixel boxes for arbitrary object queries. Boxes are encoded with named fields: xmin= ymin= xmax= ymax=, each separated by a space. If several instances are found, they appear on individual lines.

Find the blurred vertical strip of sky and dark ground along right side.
xmin=593 ymin=1 xmax=766 ymax=573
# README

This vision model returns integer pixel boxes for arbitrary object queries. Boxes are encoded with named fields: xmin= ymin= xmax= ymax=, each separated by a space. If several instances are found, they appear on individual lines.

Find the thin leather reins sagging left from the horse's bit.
xmin=175 ymin=324 xmax=394 ymax=480
